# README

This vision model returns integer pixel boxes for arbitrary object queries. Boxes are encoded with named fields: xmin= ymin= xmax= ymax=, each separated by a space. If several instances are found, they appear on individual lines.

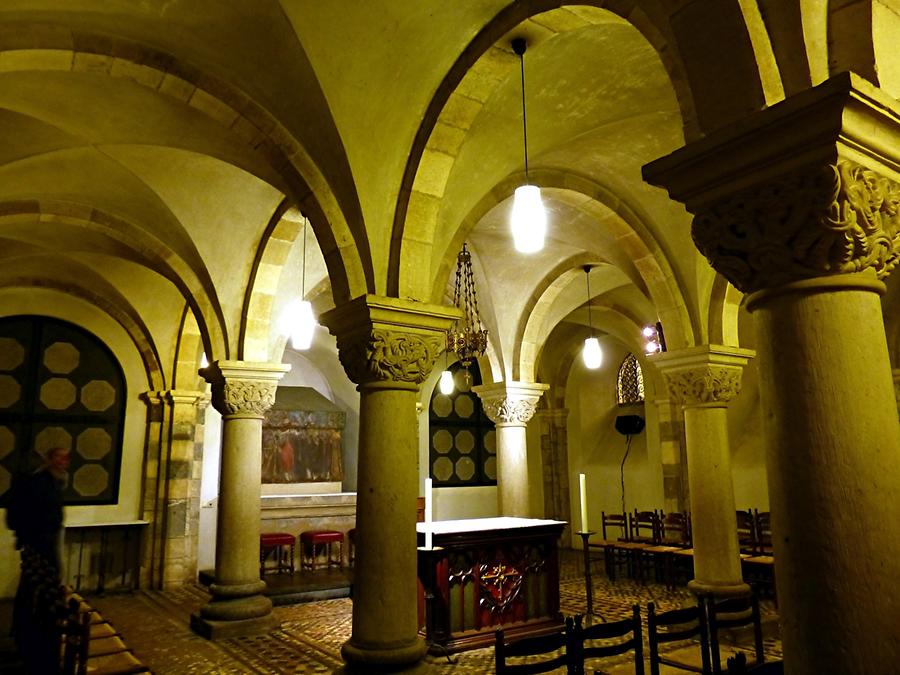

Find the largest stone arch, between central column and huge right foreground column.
xmin=387 ymin=0 xmax=775 ymax=297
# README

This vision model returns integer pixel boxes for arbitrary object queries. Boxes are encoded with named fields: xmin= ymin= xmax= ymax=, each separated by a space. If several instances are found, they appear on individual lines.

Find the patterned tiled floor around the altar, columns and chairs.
xmin=84 ymin=552 xmax=781 ymax=675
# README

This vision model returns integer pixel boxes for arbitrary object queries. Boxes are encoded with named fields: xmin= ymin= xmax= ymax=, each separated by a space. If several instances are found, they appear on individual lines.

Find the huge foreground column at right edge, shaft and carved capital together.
xmin=644 ymin=73 xmax=900 ymax=675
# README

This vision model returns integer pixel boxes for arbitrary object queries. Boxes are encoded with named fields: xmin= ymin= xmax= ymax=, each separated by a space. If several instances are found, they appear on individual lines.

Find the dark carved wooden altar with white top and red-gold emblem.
xmin=418 ymin=518 xmax=566 ymax=651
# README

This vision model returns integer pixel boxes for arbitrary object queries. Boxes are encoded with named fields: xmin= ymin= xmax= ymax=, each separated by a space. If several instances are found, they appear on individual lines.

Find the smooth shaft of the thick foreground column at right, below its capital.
xmin=751 ymin=275 xmax=900 ymax=673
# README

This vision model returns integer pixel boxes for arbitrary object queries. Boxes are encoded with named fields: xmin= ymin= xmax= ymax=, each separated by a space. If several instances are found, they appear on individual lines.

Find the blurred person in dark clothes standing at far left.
xmin=6 ymin=447 xmax=69 ymax=675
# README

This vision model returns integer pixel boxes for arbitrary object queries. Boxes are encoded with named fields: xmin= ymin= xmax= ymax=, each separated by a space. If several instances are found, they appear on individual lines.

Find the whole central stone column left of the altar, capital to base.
xmin=320 ymin=295 xmax=458 ymax=673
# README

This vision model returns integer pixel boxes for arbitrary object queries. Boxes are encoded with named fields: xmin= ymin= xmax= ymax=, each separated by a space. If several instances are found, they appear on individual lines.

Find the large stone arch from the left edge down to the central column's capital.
xmin=0 ymin=25 xmax=375 ymax=302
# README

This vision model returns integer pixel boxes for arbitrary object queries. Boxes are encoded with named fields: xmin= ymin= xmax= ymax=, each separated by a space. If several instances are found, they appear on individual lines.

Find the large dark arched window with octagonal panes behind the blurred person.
xmin=0 ymin=316 xmax=125 ymax=504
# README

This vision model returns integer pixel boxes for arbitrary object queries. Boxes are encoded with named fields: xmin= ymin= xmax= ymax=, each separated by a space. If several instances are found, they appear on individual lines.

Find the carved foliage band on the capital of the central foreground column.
xmin=339 ymin=328 xmax=445 ymax=384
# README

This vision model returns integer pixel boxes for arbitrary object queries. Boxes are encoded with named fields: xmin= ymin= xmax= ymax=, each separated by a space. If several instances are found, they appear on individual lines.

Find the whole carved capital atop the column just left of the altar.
xmin=320 ymin=295 xmax=459 ymax=389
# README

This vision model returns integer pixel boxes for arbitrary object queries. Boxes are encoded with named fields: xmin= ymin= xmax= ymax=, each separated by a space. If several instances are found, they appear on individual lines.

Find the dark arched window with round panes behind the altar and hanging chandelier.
xmin=428 ymin=362 xmax=497 ymax=487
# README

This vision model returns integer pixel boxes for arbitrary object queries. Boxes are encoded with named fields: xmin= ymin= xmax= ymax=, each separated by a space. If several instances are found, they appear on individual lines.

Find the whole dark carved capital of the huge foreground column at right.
xmin=643 ymin=73 xmax=900 ymax=293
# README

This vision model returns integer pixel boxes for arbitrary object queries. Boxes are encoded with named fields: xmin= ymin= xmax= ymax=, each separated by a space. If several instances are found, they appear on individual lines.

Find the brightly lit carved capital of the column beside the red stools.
xmin=200 ymin=361 xmax=291 ymax=418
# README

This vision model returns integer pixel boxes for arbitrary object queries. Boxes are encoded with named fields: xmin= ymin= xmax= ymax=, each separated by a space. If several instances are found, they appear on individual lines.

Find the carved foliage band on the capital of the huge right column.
xmin=692 ymin=160 xmax=900 ymax=293
